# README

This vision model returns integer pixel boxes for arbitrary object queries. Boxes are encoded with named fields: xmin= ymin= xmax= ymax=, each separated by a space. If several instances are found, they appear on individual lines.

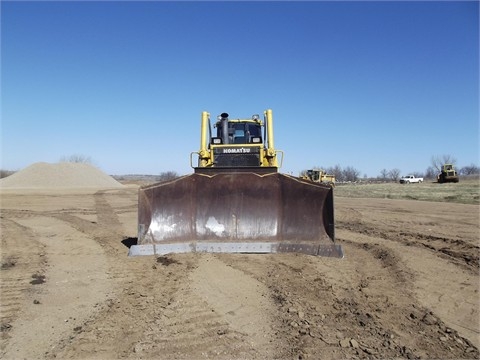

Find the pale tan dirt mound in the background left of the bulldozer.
xmin=0 ymin=162 xmax=123 ymax=188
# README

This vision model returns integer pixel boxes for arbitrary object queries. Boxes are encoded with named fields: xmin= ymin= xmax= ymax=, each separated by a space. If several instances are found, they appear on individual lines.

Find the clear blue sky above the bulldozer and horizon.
xmin=1 ymin=1 xmax=479 ymax=176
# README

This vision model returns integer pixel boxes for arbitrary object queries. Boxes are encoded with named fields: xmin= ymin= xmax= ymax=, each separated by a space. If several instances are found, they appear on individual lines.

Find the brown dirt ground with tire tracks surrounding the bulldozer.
xmin=0 ymin=186 xmax=480 ymax=359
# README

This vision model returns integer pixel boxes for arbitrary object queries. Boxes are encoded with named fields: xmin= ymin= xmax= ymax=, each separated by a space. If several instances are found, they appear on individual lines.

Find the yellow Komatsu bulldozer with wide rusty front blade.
xmin=129 ymin=110 xmax=343 ymax=258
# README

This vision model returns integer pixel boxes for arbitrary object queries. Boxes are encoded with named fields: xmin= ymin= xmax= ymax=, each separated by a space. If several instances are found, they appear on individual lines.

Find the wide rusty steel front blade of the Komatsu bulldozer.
xmin=129 ymin=172 xmax=343 ymax=258
